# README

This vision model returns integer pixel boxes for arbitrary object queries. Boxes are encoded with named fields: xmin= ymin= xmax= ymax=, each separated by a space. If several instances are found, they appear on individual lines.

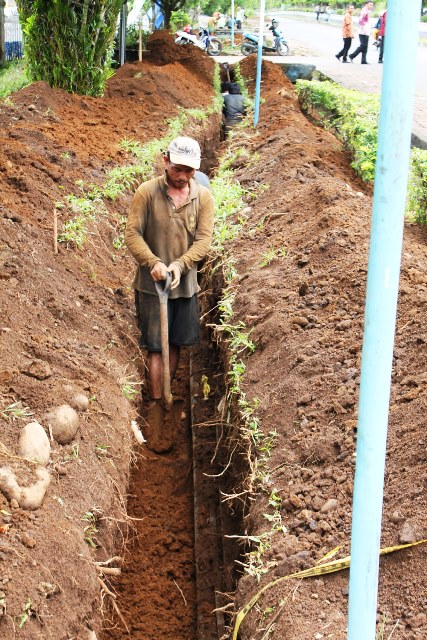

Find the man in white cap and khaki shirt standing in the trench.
xmin=125 ymin=136 xmax=214 ymax=452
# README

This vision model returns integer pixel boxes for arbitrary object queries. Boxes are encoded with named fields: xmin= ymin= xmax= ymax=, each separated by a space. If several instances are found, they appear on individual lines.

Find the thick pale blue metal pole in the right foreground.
xmin=348 ymin=0 xmax=421 ymax=640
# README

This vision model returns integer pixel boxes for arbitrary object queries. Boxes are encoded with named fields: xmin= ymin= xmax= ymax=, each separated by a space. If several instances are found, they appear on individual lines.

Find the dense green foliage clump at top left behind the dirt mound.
xmin=17 ymin=0 xmax=123 ymax=96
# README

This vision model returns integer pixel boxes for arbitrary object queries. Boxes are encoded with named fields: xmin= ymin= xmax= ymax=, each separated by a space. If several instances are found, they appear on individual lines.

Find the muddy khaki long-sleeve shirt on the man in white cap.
xmin=125 ymin=175 xmax=214 ymax=298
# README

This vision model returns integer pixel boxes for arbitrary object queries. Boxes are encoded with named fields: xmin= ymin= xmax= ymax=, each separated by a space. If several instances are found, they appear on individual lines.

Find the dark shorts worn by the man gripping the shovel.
xmin=135 ymin=291 xmax=200 ymax=352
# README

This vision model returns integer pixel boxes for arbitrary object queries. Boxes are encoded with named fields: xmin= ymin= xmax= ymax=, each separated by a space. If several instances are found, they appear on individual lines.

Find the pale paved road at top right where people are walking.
xmin=216 ymin=13 xmax=427 ymax=149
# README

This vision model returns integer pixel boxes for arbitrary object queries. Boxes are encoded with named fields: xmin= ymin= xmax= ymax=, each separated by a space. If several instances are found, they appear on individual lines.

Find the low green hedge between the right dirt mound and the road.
xmin=296 ymin=80 xmax=427 ymax=224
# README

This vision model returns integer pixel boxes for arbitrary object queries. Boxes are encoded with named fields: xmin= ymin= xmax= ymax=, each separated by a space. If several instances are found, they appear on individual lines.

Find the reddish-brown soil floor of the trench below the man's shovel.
xmin=103 ymin=354 xmax=196 ymax=640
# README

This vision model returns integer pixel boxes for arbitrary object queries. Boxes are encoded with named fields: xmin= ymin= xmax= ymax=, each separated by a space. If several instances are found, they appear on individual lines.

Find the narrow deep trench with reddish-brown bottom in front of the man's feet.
xmin=102 ymin=121 xmax=246 ymax=640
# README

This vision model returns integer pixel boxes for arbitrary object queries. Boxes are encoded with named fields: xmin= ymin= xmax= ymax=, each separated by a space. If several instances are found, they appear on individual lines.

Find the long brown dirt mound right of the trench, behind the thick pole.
xmin=224 ymin=57 xmax=427 ymax=640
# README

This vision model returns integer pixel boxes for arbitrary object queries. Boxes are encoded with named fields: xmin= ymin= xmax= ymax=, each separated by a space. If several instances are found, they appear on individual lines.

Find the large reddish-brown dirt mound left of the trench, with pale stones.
xmin=0 ymin=55 xmax=219 ymax=640
